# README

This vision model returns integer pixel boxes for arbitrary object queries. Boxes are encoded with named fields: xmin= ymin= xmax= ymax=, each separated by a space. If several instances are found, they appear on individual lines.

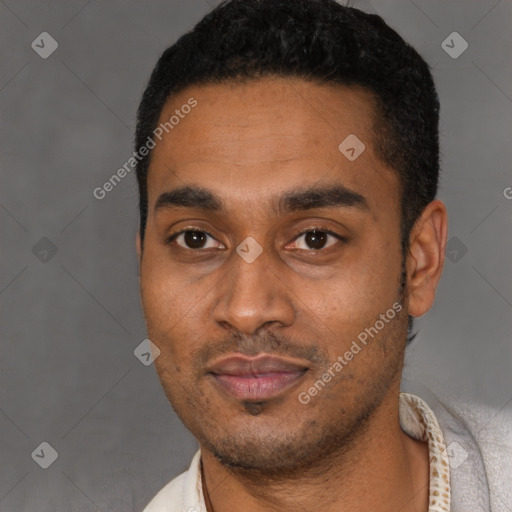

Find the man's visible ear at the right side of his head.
xmin=406 ymin=199 xmax=448 ymax=317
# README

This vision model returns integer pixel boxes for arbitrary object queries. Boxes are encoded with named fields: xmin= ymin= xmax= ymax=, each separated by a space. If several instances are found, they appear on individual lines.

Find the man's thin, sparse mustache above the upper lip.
xmin=195 ymin=331 xmax=328 ymax=369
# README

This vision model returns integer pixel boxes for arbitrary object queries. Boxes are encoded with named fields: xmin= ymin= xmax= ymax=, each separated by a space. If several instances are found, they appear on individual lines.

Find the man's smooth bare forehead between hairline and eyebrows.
xmin=148 ymin=78 xmax=397 ymax=212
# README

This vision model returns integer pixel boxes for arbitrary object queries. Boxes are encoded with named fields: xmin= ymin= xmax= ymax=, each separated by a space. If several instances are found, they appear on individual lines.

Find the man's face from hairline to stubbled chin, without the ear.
xmin=140 ymin=78 xmax=407 ymax=473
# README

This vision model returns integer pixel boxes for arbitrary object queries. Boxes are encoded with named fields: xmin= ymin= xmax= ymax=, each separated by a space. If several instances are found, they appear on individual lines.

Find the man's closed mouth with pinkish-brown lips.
xmin=208 ymin=354 xmax=308 ymax=401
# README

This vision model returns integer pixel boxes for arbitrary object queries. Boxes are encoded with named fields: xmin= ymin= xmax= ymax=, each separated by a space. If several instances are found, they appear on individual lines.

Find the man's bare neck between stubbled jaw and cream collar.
xmin=201 ymin=395 xmax=429 ymax=512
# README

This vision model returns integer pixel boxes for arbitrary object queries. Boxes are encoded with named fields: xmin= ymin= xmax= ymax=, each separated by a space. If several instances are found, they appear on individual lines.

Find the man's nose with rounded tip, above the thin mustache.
xmin=214 ymin=251 xmax=295 ymax=334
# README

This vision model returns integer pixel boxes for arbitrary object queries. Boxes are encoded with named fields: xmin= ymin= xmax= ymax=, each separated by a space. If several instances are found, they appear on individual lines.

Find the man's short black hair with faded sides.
xmin=135 ymin=0 xmax=439 ymax=346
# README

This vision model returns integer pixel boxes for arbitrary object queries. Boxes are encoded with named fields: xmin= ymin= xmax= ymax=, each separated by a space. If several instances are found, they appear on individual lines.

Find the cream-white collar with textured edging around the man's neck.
xmin=144 ymin=393 xmax=474 ymax=512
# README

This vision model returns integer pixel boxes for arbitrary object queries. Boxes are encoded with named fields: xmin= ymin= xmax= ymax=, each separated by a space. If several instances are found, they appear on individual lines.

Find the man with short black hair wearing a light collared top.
xmin=136 ymin=0 xmax=496 ymax=512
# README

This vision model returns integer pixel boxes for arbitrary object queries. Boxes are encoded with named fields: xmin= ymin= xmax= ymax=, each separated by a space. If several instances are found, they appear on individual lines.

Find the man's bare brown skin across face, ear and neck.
xmin=136 ymin=78 xmax=447 ymax=512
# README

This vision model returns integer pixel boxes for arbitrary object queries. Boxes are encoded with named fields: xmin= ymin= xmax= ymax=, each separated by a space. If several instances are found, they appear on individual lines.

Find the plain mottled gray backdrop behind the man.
xmin=0 ymin=0 xmax=512 ymax=512
